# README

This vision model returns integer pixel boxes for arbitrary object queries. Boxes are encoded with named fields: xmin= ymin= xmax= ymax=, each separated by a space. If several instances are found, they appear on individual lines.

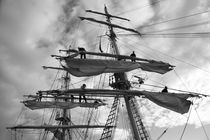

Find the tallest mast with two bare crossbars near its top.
xmin=83 ymin=6 xmax=151 ymax=140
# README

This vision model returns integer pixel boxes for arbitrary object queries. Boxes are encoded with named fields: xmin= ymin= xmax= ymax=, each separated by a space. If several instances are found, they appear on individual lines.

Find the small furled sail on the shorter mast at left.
xmin=23 ymin=100 xmax=106 ymax=110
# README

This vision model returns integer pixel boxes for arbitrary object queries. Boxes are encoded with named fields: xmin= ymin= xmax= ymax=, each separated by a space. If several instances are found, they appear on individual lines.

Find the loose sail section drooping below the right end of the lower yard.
xmin=141 ymin=91 xmax=198 ymax=114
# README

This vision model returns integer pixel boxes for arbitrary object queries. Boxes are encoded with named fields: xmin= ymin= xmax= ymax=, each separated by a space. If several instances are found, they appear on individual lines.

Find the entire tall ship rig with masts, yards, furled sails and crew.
xmin=7 ymin=6 xmax=208 ymax=140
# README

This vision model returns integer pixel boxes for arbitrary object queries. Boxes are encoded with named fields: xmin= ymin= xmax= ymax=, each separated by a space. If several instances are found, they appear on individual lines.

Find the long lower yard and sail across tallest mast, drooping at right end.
xmin=32 ymin=89 xmax=198 ymax=114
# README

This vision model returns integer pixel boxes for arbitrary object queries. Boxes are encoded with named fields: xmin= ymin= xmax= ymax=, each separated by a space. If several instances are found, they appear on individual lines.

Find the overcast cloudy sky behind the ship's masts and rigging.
xmin=0 ymin=0 xmax=210 ymax=140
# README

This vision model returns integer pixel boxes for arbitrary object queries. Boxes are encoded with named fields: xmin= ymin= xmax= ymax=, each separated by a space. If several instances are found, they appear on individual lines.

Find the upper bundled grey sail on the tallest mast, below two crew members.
xmin=63 ymin=58 xmax=172 ymax=77
